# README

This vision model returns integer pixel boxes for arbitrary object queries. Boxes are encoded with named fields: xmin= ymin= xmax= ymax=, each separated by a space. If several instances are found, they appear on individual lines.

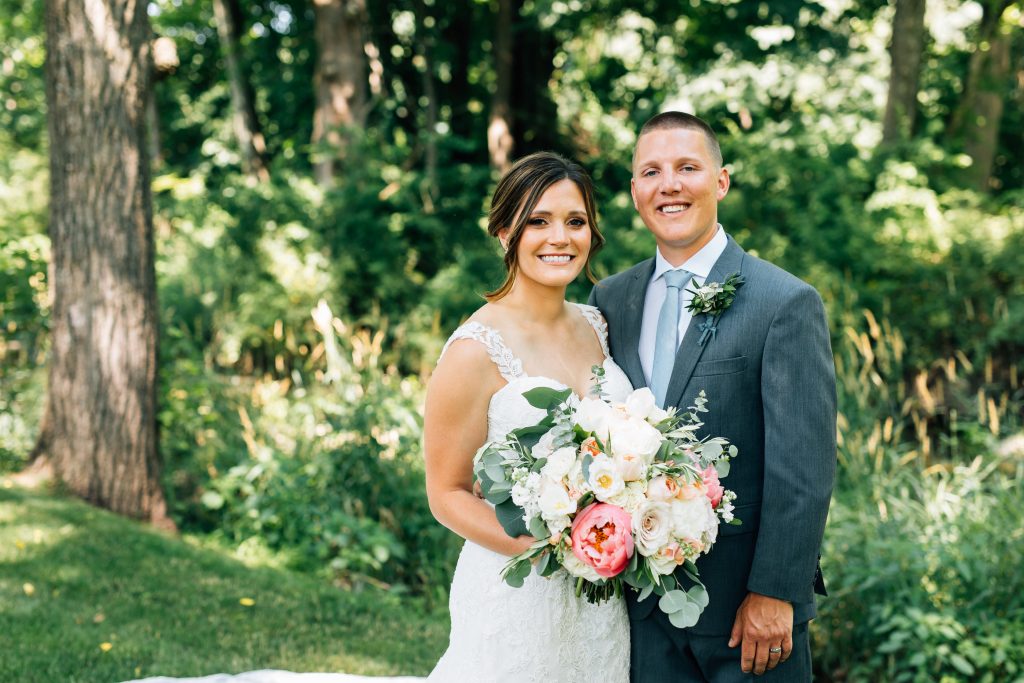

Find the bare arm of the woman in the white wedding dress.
xmin=423 ymin=340 xmax=534 ymax=556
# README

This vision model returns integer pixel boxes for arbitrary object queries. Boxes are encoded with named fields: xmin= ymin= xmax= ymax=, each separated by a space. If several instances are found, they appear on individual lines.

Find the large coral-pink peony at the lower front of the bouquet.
xmin=572 ymin=503 xmax=633 ymax=579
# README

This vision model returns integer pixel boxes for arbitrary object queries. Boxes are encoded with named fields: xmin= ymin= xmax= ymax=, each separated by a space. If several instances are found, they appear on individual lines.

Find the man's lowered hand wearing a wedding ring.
xmin=729 ymin=593 xmax=793 ymax=675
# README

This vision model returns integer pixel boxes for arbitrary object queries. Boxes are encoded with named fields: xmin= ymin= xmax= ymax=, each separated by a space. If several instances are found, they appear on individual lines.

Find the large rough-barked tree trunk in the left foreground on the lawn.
xmin=37 ymin=0 xmax=168 ymax=524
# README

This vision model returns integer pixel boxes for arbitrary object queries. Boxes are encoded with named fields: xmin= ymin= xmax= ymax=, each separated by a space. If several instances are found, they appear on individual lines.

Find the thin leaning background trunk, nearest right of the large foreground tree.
xmin=213 ymin=0 xmax=270 ymax=180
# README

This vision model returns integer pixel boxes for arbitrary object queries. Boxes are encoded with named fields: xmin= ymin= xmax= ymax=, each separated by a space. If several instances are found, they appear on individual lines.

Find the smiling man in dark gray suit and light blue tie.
xmin=590 ymin=112 xmax=836 ymax=683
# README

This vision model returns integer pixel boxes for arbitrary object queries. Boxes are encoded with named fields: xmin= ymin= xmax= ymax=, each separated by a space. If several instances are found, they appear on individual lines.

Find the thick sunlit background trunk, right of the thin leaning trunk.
xmin=312 ymin=0 xmax=368 ymax=186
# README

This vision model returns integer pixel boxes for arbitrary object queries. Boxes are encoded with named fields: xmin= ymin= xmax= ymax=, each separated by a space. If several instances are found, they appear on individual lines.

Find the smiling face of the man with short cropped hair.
xmin=630 ymin=128 xmax=729 ymax=266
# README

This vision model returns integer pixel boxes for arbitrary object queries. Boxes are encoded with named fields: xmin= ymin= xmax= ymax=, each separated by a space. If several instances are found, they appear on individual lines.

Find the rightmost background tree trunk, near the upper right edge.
xmin=950 ymin=0 xmax=1013 ymax=191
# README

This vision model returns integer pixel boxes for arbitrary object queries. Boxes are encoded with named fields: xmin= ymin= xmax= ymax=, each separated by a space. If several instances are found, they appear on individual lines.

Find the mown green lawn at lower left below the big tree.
xmin=0 ymin=482 xmax=447 ymax=683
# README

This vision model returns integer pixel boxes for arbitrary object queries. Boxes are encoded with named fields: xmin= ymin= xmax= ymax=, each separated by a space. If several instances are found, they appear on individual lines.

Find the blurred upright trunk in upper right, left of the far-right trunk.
xmin=882 ymin=0 xmax=927 ymax=143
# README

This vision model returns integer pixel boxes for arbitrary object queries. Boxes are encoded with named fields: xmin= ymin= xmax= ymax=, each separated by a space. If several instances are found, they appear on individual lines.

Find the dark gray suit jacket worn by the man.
xmin=590 ymin=237 xmax=836 ymax=635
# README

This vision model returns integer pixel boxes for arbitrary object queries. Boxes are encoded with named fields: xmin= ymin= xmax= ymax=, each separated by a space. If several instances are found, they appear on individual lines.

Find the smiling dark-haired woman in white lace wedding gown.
xmin=424 ymin=153 xmax=631 ymax=683
